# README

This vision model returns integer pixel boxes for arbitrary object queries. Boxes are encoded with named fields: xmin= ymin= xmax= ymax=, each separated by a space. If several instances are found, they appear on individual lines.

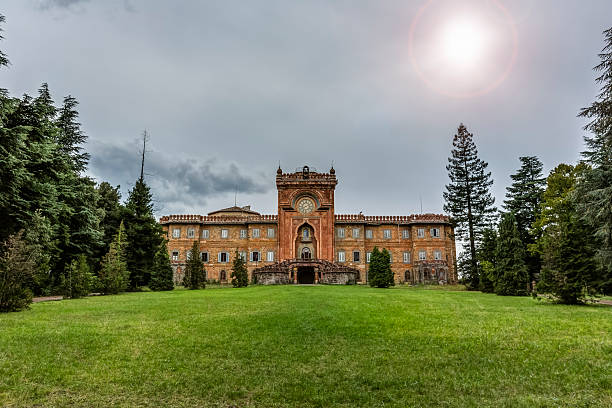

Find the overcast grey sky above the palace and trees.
xmin=0 ymin=0 xmax=612 ymax=215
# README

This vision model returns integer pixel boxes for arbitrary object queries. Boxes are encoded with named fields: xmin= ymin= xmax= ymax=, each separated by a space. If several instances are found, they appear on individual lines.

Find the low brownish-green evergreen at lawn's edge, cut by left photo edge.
xmin=0 ymin=231 xmax=36 ymax=312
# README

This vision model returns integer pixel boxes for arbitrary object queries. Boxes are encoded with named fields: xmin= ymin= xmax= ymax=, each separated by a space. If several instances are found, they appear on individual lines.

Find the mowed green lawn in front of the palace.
xmin=0 ymin=286 xmax=612 ymax=407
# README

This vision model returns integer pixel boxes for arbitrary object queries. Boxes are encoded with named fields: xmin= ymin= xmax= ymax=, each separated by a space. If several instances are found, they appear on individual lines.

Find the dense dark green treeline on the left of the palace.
xmin=0 ymin=16 xmax=173 ymax=311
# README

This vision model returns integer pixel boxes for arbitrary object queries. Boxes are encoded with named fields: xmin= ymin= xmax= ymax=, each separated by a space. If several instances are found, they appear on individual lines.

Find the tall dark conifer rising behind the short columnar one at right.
xmin=504 ymin=156 xmax=546 ymax=281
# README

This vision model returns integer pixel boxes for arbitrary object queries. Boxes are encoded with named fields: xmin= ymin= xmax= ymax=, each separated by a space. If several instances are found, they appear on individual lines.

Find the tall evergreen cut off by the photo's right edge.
xmin=577 ymin=28 xmax=612 ymax=293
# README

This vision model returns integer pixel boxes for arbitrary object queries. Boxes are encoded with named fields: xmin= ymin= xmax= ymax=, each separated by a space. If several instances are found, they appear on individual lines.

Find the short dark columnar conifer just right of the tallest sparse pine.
xmin=495 ymin=213 xmax=529 ymax=296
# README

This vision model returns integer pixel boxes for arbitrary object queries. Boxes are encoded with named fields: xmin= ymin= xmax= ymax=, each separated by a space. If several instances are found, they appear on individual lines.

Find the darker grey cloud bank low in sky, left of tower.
xmin=89 ymin=142 xmax=270 ymax=212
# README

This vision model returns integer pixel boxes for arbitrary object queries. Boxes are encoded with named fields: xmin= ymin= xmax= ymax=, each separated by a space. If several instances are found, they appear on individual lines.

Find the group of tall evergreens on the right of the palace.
xmin=444 ymin=28 xmax=612 ymax=304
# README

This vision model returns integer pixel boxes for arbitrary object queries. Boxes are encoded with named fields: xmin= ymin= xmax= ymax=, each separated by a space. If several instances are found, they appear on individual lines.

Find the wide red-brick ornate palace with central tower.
xmin=160 ymin=166 xmax=457 ymax=284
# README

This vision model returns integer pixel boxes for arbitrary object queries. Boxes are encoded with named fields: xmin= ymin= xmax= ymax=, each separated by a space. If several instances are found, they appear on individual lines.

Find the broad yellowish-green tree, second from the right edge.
xmin=530 ymin=164 xmax=602 ymax=304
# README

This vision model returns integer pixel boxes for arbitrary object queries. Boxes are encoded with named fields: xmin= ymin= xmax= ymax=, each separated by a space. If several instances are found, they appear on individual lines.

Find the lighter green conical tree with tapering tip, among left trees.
xmin=98 ymin=223 xmax=130 ymax=295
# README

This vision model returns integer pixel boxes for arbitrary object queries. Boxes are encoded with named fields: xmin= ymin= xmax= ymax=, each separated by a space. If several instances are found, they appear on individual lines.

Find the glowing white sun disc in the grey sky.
xmin=440 ymin=19 xmax=486 ymax=69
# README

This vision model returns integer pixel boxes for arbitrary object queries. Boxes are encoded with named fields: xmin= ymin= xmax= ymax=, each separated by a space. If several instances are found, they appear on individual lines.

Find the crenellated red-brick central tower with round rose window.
xmin=276 ymin=166 xmax=338 ymax=262
